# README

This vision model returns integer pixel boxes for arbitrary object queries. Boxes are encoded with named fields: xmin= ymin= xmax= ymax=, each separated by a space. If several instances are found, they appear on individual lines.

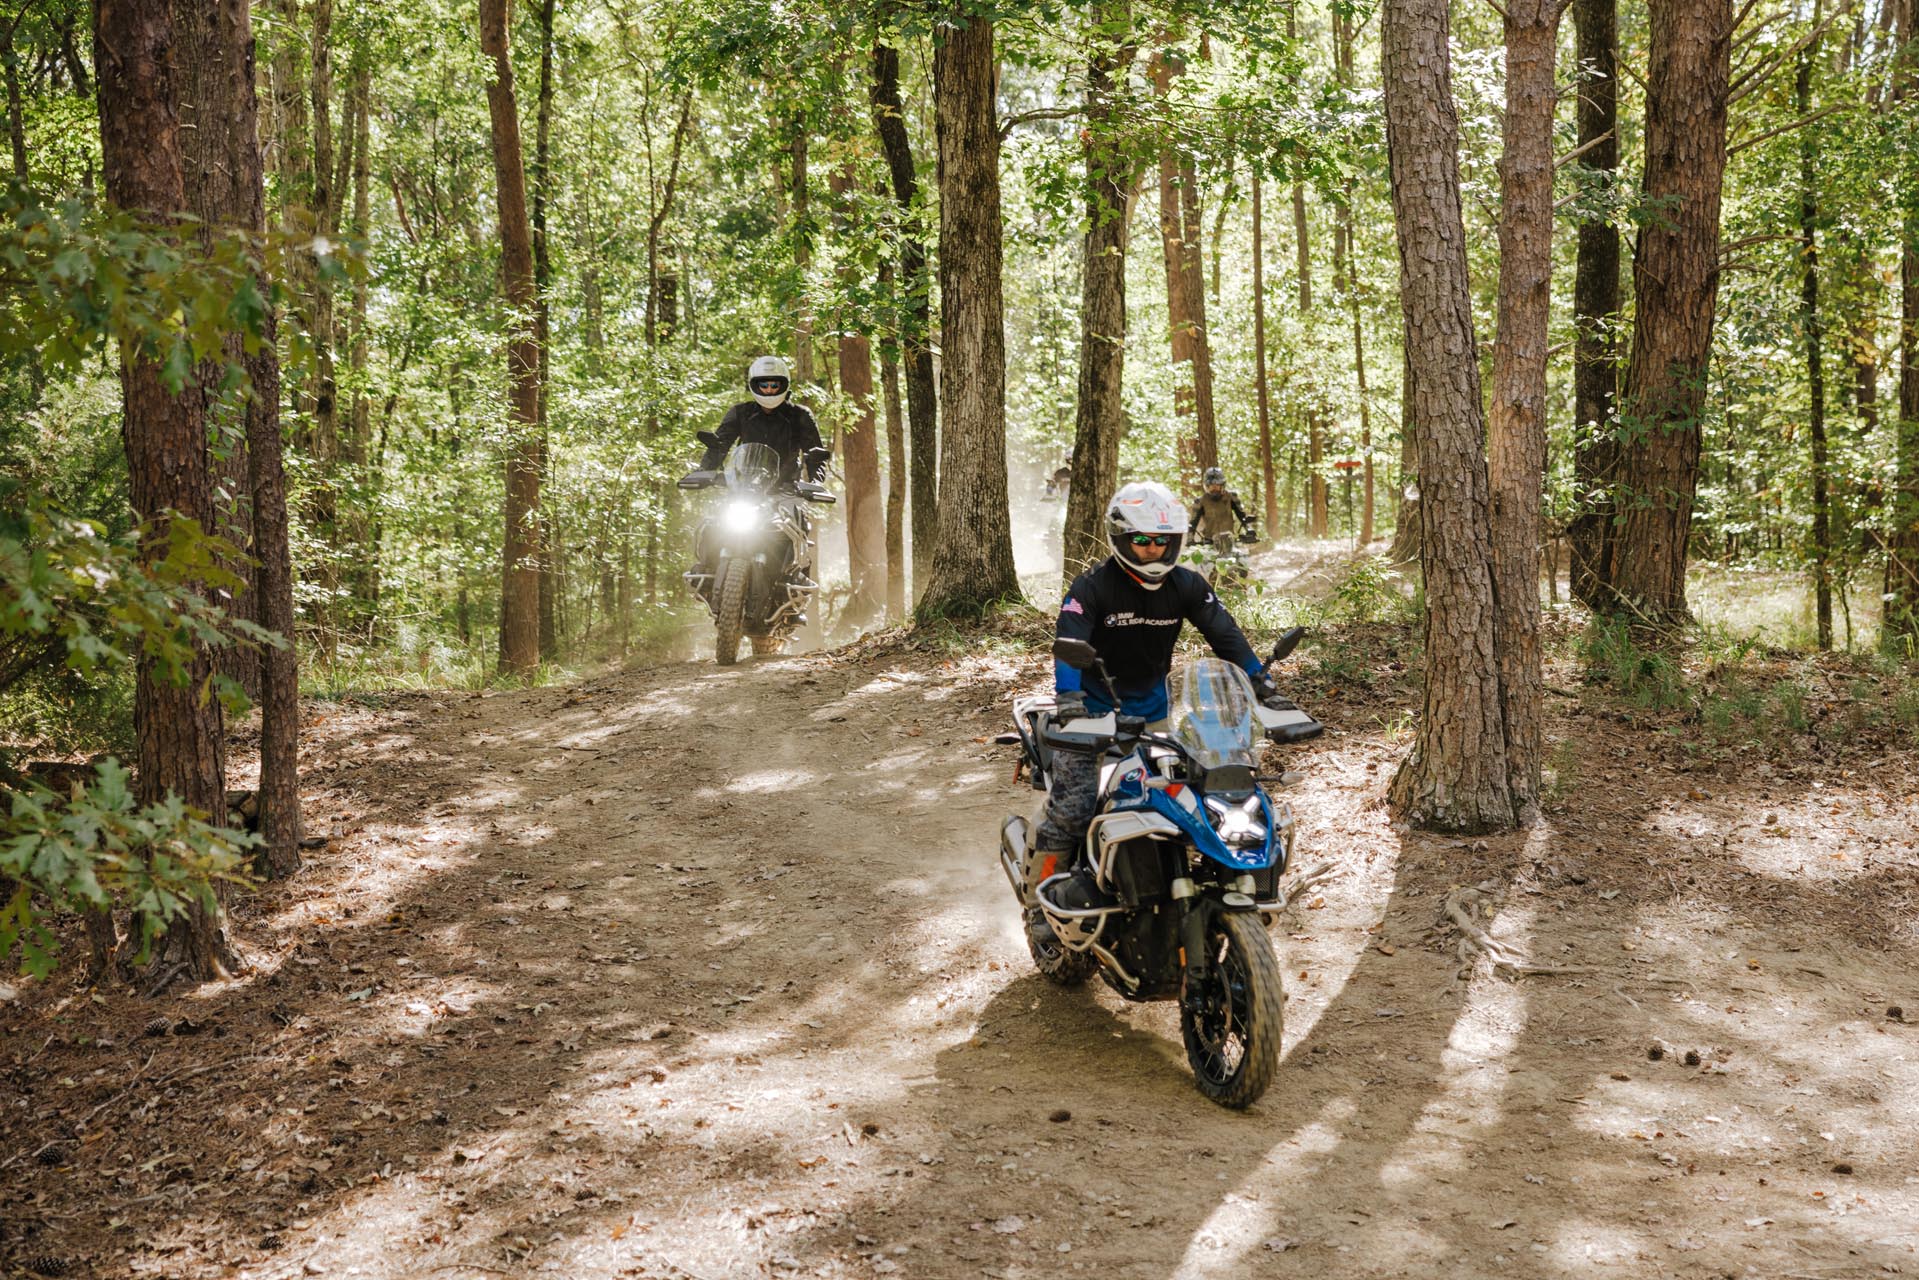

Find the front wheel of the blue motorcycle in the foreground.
xmin=1180 ymin=912 xmax=1286 ymax=1109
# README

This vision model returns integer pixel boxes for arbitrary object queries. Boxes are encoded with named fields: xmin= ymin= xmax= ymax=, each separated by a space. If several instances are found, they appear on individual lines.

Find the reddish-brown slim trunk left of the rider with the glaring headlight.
xmin=479 ymin=0 xmax=539 ymax=676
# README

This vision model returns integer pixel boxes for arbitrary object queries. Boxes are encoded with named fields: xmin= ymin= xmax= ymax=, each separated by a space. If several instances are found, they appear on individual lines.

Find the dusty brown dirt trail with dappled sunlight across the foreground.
xmin=0 ymin=621 xmax=1919 ymax=1280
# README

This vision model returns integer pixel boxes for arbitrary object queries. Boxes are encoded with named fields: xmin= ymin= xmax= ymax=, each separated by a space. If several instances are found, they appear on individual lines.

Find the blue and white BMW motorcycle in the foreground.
xmin=1000 ymin=628 xmax=1324 ymax=1107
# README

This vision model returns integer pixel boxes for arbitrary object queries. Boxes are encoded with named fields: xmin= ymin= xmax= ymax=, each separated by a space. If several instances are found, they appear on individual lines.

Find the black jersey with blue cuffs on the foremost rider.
xmin=1054 ymin=557 xmax=1265 ymax=720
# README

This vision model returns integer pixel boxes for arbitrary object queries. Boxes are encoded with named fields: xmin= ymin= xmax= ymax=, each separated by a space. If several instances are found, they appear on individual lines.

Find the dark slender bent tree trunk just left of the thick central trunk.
xmin=867 ymin=44 xmax=940 ymax=597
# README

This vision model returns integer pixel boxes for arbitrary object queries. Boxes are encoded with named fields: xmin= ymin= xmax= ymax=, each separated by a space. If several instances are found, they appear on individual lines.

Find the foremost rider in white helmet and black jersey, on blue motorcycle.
xmin=1029 ymin=484 xmax=1291 ymax=909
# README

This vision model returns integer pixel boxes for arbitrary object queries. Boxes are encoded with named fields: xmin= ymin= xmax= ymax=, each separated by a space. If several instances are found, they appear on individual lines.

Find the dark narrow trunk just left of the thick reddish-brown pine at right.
xmin=1566 ymin=0 xmax=1620 ymax=608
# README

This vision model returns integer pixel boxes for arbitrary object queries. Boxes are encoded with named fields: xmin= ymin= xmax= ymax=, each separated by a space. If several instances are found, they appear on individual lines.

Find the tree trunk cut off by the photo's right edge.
xmin=1879 ymin=0 xmax=1919 ymax=656
